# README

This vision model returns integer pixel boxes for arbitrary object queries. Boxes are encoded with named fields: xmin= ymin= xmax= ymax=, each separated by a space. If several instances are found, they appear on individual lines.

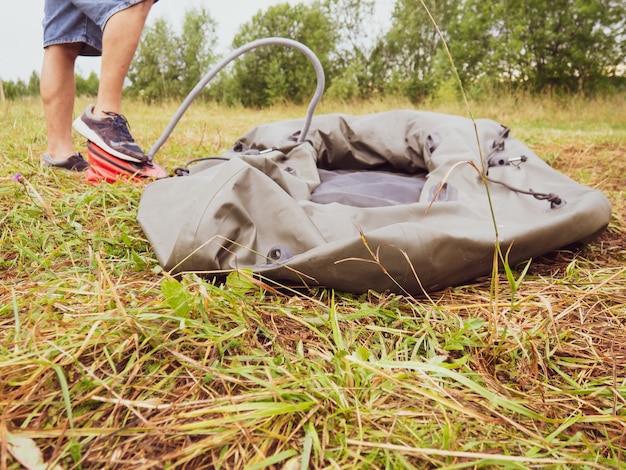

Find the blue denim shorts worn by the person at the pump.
xmin=43 ymin=0 xmax=155 ymax=56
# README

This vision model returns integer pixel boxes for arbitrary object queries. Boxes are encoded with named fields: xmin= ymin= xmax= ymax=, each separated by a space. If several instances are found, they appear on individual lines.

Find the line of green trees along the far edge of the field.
xmin=4 ymin=0 xmax=626 ymax=107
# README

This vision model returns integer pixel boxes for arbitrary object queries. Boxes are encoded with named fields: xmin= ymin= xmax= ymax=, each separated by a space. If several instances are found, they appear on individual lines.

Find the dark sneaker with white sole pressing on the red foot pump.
xmin=73 ymin=105 xmax=149 ymax=163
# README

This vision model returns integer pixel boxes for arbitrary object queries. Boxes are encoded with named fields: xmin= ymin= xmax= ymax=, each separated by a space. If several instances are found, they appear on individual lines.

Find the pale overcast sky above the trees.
xmin=0 ymin=0 xmax=332 ymax=80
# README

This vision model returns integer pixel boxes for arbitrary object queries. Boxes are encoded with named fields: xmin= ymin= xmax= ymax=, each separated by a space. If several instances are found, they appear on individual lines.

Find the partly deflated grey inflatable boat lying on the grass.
xmin=138 ymin=110 xmax=611 ymax=295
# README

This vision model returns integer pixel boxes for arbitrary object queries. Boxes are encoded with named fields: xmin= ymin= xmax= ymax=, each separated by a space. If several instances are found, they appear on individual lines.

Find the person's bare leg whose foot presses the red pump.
xmin=93 ymin=0 xmax=153 ymax=116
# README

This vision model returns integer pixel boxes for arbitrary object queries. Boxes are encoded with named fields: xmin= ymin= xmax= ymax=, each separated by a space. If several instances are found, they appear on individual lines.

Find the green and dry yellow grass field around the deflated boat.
xmin=0 ymin=92 xmax=626 ymax=470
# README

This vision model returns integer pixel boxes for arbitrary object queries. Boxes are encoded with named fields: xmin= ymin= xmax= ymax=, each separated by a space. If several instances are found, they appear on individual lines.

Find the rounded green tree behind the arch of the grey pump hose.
xmin=219 ymin=3 xmax=336 ymax=107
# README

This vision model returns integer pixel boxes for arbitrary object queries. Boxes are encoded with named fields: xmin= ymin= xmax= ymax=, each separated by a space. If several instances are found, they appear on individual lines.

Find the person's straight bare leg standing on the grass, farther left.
xmin=40 ymin=43 xmax=81 ymax=160
